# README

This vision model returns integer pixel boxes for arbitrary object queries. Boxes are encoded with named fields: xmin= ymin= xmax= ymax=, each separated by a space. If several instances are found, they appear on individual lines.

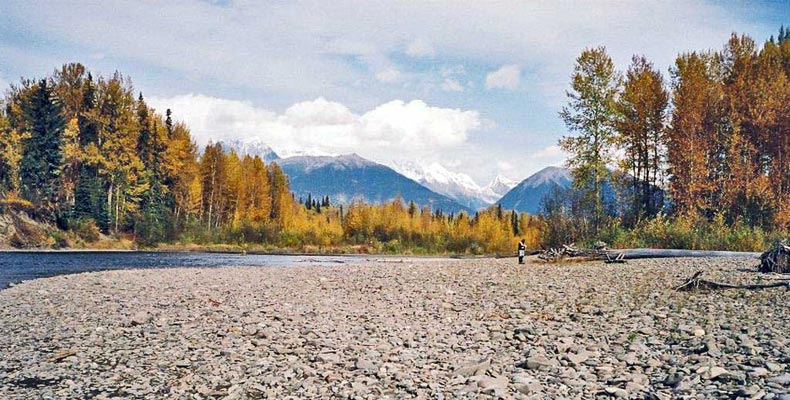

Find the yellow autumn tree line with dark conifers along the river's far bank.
xmin=0 ymin=63 xmax=540 ymax=253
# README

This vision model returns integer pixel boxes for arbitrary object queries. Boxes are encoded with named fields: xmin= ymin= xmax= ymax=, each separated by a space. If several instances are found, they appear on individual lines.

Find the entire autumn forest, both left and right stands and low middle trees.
xmin=0 ymin=27 xmax=790 ymax=254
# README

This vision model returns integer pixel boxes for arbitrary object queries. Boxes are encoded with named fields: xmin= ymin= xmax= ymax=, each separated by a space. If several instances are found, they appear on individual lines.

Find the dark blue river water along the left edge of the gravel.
xmin=0 ymin=251 xmax=397 ymax=289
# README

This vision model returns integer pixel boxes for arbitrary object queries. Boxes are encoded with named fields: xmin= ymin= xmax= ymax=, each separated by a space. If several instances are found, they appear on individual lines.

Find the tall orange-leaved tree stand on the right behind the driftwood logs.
xmin=545 ymin=27 xmax=790 ymax=247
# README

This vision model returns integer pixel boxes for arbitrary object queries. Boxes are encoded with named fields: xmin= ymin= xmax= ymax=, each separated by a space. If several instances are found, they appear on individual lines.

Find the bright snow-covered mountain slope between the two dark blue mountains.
xmin=391 ymin=162 xmax=500 ymax=210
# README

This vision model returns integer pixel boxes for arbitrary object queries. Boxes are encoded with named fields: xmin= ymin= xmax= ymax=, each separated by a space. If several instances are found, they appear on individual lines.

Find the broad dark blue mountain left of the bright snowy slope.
xmin=276 ymin=154 xmax=472 ymax=213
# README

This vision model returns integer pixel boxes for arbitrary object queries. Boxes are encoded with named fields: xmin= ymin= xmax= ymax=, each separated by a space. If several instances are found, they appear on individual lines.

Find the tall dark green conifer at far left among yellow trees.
xmin=19 ymin=80 xmax=66 ymax=218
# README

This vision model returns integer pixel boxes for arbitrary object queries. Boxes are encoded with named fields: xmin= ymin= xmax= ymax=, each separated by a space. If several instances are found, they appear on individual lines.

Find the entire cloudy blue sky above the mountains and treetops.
xmin=0 ymin=0 xmax=790 ymax=185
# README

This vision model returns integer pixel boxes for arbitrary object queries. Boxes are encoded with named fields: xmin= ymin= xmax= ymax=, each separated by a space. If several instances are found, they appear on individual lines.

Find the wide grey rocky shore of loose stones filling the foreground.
xmin=0 ymin=258 xmax=790 ymax=400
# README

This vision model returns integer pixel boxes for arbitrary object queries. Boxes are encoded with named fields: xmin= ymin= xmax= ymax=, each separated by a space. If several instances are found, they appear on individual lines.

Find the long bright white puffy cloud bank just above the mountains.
xmin=148 ymin=94 xmax=487 ymax=162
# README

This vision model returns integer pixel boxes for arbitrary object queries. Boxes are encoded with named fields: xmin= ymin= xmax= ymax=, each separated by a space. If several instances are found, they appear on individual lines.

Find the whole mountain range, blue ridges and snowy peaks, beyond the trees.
xmin=221 ymin=140 xmax=571 ymax=214
